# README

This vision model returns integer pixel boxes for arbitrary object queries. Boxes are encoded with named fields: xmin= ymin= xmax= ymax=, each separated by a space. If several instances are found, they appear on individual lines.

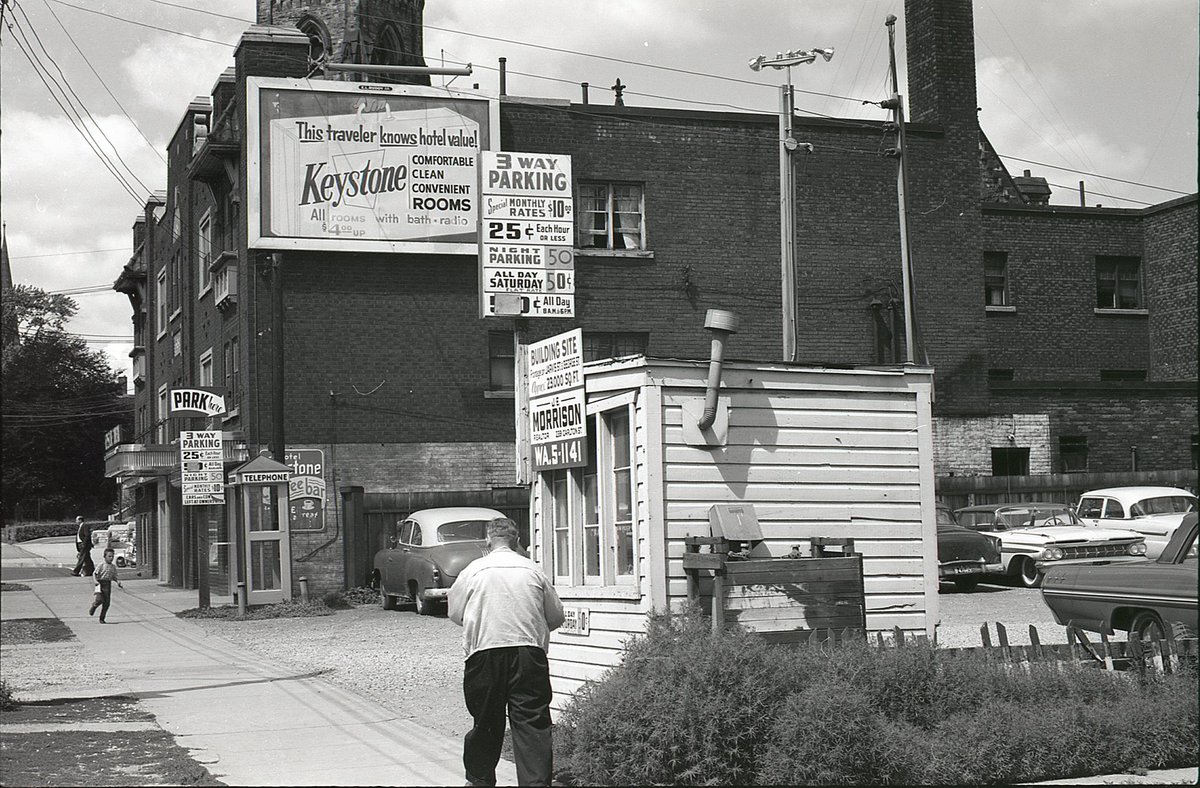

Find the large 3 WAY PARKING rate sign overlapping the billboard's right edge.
xmin=479 ymin=151 xmax=575 ymax=318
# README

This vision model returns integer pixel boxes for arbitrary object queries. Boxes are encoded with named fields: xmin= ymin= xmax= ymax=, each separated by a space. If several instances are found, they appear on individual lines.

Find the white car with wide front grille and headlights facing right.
xmin=954 ymin=501 xmax=1146 ymax=588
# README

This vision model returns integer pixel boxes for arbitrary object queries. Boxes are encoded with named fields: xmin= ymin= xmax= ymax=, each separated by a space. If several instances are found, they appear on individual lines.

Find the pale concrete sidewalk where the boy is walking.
xmin=0 ymin=543 xmax=516 ymax=786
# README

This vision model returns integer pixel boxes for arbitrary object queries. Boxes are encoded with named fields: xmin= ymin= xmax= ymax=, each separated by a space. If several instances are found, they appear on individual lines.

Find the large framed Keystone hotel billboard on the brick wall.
xmin=246 ymin=78 xmax=499 ymax=254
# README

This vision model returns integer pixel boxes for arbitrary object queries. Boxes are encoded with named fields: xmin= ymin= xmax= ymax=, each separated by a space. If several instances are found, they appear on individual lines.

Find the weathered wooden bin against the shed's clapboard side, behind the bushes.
xmin=683 ymin=536 xmax=866 ymax=643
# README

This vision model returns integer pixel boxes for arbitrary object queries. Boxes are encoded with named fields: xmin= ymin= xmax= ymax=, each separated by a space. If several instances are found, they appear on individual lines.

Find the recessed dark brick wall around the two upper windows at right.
xmin=980 ymin=206 xmax=1152 ymax=381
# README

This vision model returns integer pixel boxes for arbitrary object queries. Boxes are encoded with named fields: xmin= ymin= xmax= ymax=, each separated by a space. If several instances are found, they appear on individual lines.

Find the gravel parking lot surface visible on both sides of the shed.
xmin=196 ymin=575 xmax=1066 ymax=736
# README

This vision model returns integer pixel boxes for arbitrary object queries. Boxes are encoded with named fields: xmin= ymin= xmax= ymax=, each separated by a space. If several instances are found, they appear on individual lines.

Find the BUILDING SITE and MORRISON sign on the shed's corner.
xmin=528 ymin=329 xmax=588 ymax=470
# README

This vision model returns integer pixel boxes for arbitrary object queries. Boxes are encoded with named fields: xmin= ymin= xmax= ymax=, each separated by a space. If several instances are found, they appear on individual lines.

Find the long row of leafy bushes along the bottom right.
xmin=556 ymin=610 xmax=1200 ymax=784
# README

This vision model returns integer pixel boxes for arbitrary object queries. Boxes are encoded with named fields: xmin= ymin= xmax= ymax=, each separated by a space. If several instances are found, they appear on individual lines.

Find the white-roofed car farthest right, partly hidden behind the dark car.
xmin=1075 ymin=487 xmax=1196 ymax=558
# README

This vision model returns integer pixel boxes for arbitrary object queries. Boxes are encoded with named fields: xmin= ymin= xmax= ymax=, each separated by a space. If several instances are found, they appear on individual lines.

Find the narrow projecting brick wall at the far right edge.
xmin=1144 ymin=197 xmax=1200 ymax=379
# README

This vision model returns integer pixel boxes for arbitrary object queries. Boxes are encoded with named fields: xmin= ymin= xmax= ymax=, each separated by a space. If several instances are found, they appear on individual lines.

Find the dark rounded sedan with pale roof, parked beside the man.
xmin=371 ymin=506 xmax=504 ymax=615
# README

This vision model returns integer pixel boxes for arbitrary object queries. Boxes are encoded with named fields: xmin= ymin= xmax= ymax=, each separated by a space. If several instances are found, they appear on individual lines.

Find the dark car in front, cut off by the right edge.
xmin=1042 ymin=512 xmax=1196 ymax=638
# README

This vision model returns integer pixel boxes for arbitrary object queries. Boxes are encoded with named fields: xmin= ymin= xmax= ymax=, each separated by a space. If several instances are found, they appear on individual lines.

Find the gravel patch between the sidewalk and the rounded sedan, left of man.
xmin=193 ymin=604 xmax=470 ymax=736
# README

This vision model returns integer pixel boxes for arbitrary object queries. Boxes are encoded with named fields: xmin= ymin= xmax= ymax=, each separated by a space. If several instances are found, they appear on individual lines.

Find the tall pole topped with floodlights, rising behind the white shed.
xmin=750 ymin=47 xmax=833 ymax=363
